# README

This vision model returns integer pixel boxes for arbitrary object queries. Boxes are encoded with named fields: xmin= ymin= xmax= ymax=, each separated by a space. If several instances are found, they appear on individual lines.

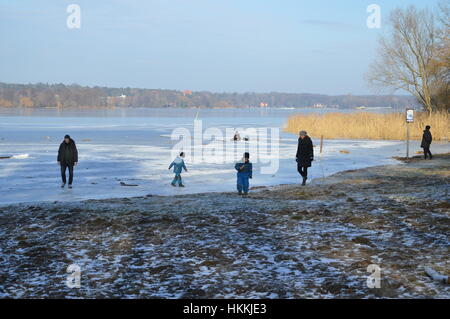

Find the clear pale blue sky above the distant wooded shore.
xmin=0 ymin=0 xmax=438 ymax=94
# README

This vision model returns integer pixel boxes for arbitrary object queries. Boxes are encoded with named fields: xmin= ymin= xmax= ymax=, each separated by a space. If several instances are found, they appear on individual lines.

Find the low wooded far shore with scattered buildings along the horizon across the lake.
xmin=0 ymin=82 xmax=418 ymax=108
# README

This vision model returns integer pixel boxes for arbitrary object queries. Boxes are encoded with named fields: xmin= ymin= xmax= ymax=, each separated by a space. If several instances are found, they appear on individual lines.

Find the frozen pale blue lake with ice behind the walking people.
xmin=0 ymin=109 xmax=449 ymax=204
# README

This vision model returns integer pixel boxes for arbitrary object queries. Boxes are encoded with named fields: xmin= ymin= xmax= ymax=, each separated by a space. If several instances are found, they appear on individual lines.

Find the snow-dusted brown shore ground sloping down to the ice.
xmin=0 ymin=154 xmax=450 ymax=298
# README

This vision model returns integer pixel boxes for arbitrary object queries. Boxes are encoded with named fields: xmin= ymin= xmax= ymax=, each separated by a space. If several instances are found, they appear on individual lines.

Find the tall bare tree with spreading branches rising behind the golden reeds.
xmin=366 ymin=6 xmax=438 ymax=112
